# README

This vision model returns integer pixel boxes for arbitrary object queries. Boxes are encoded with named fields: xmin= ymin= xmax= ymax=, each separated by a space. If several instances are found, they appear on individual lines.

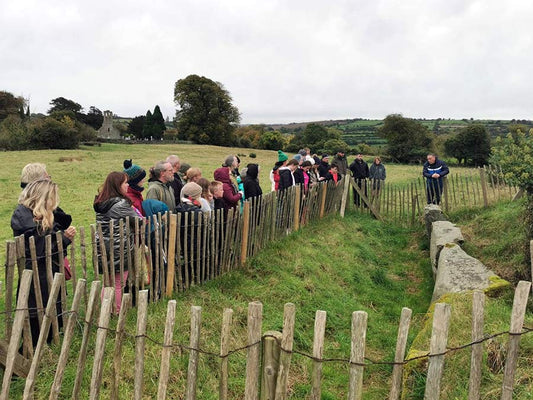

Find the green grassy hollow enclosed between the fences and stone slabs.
xmin=7 ymin=215 xmax=432 ymax=399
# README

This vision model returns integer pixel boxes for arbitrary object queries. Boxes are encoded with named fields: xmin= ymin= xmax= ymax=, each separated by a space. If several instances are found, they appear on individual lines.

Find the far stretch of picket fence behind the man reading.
xmin=350 ymin=165 xmax=519 ymax=224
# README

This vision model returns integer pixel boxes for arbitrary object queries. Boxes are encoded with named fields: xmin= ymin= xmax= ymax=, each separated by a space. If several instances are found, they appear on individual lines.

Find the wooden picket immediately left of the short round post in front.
xmin=244 ymin=301 xmax=263 ymax=400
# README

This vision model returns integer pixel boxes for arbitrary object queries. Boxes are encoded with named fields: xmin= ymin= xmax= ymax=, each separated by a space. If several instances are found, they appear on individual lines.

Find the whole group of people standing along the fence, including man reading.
xmin=11 ymin=149 xmax=449 ymax=345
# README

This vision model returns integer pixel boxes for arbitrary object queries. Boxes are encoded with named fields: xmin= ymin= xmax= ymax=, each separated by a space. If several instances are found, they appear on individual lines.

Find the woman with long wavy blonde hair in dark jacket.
xmin=11 ymin=179 xmax=76 ymax=347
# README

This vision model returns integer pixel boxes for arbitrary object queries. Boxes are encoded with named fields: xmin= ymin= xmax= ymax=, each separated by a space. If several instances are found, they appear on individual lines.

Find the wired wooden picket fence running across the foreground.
xmin=0 ymin=270 xmax=533 ymax=400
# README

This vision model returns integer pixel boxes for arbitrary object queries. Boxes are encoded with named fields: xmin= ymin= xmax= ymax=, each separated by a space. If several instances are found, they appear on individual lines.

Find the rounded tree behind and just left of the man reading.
xmin=378 ymin=114 xmax=433 ymax=162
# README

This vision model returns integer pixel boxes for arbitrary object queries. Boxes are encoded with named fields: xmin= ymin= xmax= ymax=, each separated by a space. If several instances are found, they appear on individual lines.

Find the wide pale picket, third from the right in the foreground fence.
xmin=424 ymin=303 xmax=451 ymax=400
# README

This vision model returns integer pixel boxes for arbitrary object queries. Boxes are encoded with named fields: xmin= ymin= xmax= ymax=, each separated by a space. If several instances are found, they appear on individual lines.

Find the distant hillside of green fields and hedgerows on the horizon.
xmin=265 ymin=118 xmax=533 ymax=146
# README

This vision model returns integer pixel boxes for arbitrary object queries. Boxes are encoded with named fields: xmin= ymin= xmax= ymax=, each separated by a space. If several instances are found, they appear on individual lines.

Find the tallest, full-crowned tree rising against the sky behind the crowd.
xmin=174 ymin=75 xmax=240 ymax=146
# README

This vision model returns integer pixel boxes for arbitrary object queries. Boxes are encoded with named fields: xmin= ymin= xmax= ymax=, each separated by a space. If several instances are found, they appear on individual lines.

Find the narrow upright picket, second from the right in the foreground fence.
xmin=468 ymin=290 xmax=485 ymax=400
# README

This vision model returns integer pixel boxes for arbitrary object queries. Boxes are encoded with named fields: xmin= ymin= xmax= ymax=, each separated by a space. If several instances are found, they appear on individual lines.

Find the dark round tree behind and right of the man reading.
xmin=444 ymin=124 xmax=490 ymax=166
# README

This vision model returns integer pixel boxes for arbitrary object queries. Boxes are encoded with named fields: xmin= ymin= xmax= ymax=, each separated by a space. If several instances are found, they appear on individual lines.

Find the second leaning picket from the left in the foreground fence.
xmin=22 ymin=273 xmax=65 ymax=400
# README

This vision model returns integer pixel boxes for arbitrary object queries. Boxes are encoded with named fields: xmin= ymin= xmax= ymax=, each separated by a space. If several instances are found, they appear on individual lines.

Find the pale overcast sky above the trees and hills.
xmin=0 ymin=0 xmax=533 ymax=123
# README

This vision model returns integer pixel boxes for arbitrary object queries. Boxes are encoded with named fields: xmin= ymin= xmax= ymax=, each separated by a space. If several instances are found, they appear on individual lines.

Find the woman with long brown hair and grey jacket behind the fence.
xmin=93 ymin=172 xmax=139 ymax=313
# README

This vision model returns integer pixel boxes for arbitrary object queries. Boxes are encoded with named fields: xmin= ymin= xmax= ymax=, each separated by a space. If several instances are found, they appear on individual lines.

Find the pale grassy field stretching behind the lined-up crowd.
xmin=0 ymin=144 xmax=480 ymax=248
